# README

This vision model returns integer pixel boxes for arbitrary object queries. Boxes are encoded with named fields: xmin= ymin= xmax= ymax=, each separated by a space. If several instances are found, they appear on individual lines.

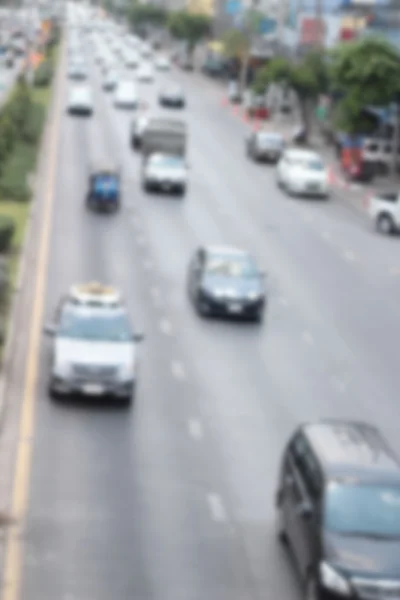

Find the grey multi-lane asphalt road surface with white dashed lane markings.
xmin=11 ymin=38 xmax=400 ymax=600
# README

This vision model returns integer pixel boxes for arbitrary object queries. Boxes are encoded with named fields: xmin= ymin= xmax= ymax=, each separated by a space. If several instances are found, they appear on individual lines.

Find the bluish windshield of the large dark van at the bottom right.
xmin=324 ymin=482 xmax=400 ymax=538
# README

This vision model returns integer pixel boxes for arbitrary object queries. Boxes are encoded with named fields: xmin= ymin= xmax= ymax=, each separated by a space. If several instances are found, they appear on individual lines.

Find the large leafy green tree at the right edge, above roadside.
xmin=330 ymin=36 xmax=400 ymax=134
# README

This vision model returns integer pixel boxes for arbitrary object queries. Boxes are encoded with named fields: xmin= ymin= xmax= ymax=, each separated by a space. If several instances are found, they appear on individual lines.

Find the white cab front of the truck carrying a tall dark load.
xmin=142 ymin=154 xmax=188 ymax=196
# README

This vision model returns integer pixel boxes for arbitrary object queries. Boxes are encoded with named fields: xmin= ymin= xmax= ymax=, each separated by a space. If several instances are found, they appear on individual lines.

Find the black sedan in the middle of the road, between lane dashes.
xmin=188 ymin=246 xmax=266 ymax=322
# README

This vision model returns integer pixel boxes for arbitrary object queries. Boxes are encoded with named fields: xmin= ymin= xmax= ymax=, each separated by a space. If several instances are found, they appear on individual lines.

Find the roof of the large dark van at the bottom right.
xmin=301 ymin=420 xmax=400 ymax=484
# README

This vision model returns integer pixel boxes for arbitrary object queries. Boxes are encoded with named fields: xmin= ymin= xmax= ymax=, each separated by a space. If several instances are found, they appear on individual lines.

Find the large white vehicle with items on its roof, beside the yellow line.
xmin=45 ymin=283 xmax=143 ymax=405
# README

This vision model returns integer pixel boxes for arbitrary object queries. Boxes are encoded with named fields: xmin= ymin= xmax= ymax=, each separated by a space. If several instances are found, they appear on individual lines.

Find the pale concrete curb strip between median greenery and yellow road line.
xmin=0 ymin=40 xmax=64 ymax=429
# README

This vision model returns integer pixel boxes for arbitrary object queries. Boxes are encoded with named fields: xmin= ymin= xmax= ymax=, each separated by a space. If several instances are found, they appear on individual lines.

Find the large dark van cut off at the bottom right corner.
xmin=276 ymin=421 xmax=400 ymax=600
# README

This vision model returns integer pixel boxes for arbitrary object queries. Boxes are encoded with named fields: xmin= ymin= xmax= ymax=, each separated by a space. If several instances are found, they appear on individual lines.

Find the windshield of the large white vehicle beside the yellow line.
xmin=58 ymin=310 xmax=133 ymax=342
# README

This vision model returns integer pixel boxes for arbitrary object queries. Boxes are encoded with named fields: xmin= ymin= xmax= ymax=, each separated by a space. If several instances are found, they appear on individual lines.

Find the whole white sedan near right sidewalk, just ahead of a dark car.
xmin=276 ymin=148 xmax=329 ymax=198
